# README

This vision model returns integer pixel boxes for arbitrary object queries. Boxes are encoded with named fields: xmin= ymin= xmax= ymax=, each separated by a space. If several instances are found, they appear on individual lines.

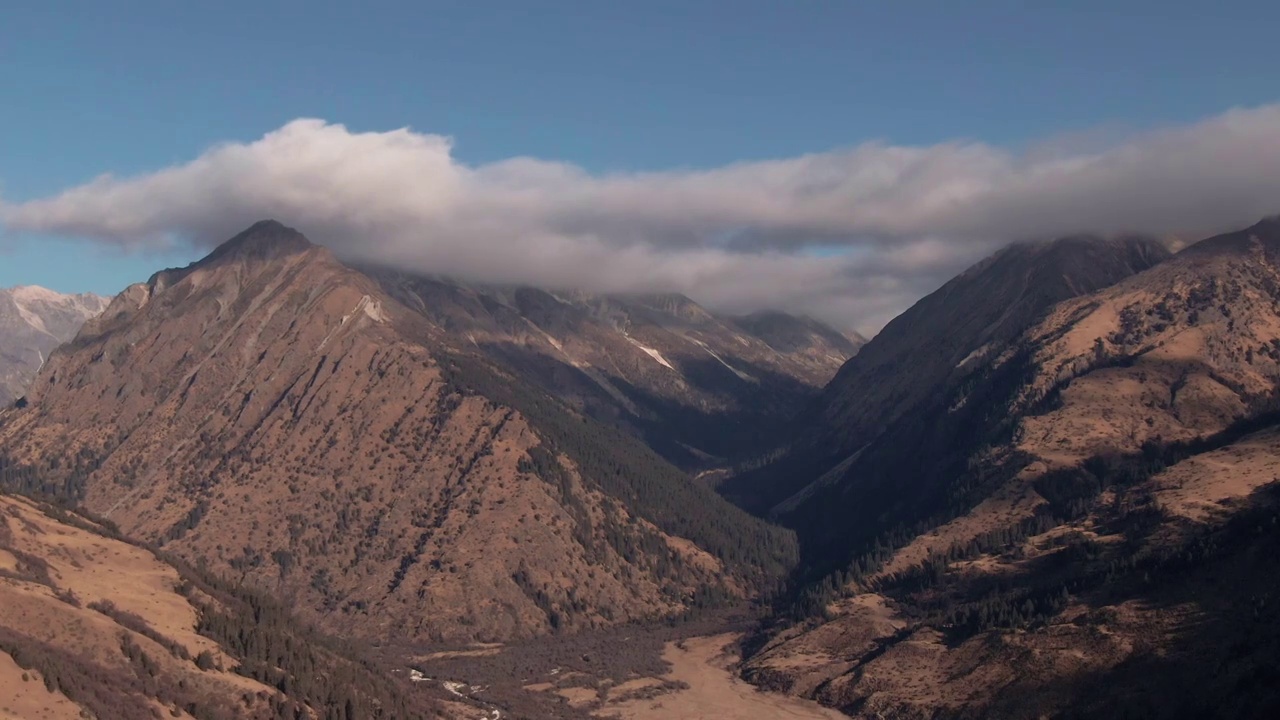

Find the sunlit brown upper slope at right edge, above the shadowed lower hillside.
xmin=1015 ymin=218 xmax=1280 ymax=462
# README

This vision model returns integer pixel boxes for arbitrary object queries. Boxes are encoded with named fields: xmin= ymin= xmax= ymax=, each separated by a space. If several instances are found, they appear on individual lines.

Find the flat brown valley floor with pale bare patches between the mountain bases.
xmin=385 ymin=616 xmax=845 ymax=720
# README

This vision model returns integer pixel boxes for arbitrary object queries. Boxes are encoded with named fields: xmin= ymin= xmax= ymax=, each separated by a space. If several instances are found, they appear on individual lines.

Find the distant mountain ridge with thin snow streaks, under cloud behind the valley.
xmin=371 ymin=272 xmax=865 ymax=469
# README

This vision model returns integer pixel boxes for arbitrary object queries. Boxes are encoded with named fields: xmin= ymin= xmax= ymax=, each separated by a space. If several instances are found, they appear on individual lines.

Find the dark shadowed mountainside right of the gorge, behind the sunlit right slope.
xmin=722 ymin=236 xmax=1169 ymax=514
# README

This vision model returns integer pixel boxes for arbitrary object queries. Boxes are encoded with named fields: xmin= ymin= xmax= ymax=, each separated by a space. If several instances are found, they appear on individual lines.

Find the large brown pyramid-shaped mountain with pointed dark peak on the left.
xmin=0 ymin=222 xmax=795 ymax=641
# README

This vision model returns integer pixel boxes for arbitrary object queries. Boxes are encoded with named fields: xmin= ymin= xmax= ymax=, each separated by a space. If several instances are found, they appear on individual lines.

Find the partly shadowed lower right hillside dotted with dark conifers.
xmin=744 ymin=414 xmax=1280 ymax=719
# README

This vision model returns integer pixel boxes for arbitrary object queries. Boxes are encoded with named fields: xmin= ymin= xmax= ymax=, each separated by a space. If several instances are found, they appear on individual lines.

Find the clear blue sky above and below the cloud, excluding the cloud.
xmin=0 ymin=0 xmax=1280 ymax=327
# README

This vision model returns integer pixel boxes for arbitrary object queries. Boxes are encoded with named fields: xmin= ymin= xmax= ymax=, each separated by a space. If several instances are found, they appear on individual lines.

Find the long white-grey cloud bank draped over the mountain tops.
xmin=0 ymin=105 xmax=1280 ymax=332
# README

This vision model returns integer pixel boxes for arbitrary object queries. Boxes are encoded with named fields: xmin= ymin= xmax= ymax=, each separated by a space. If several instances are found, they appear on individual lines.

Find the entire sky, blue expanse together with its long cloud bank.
xmin=0 ymin=0 xmax=1280 ymax=333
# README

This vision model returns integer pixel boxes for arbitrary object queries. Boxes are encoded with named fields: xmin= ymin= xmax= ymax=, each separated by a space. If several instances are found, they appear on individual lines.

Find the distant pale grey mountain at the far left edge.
xmin=0 ymin=286 xmax=108 ymax=406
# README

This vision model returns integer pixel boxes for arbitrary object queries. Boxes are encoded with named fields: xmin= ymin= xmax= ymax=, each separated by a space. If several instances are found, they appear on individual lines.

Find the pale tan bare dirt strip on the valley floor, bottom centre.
xmin=596 ymin=633 xmax=846 ymax=720
